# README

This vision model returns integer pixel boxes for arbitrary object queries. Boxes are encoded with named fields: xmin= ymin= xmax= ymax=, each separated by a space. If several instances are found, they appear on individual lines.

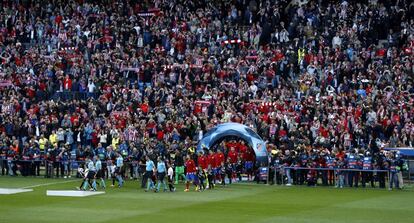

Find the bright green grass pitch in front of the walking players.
xmin=0 ymin=177 xmax=414 ymax=223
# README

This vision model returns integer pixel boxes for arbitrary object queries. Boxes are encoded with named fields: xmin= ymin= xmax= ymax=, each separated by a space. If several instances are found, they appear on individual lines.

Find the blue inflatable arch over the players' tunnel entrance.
xmin=197 ymin=122 xmax=268 ymax=164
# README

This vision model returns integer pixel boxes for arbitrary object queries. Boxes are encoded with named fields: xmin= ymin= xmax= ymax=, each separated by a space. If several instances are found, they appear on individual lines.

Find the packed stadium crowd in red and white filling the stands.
xmin=0 ymin=0 xmax=414 ymax=189
